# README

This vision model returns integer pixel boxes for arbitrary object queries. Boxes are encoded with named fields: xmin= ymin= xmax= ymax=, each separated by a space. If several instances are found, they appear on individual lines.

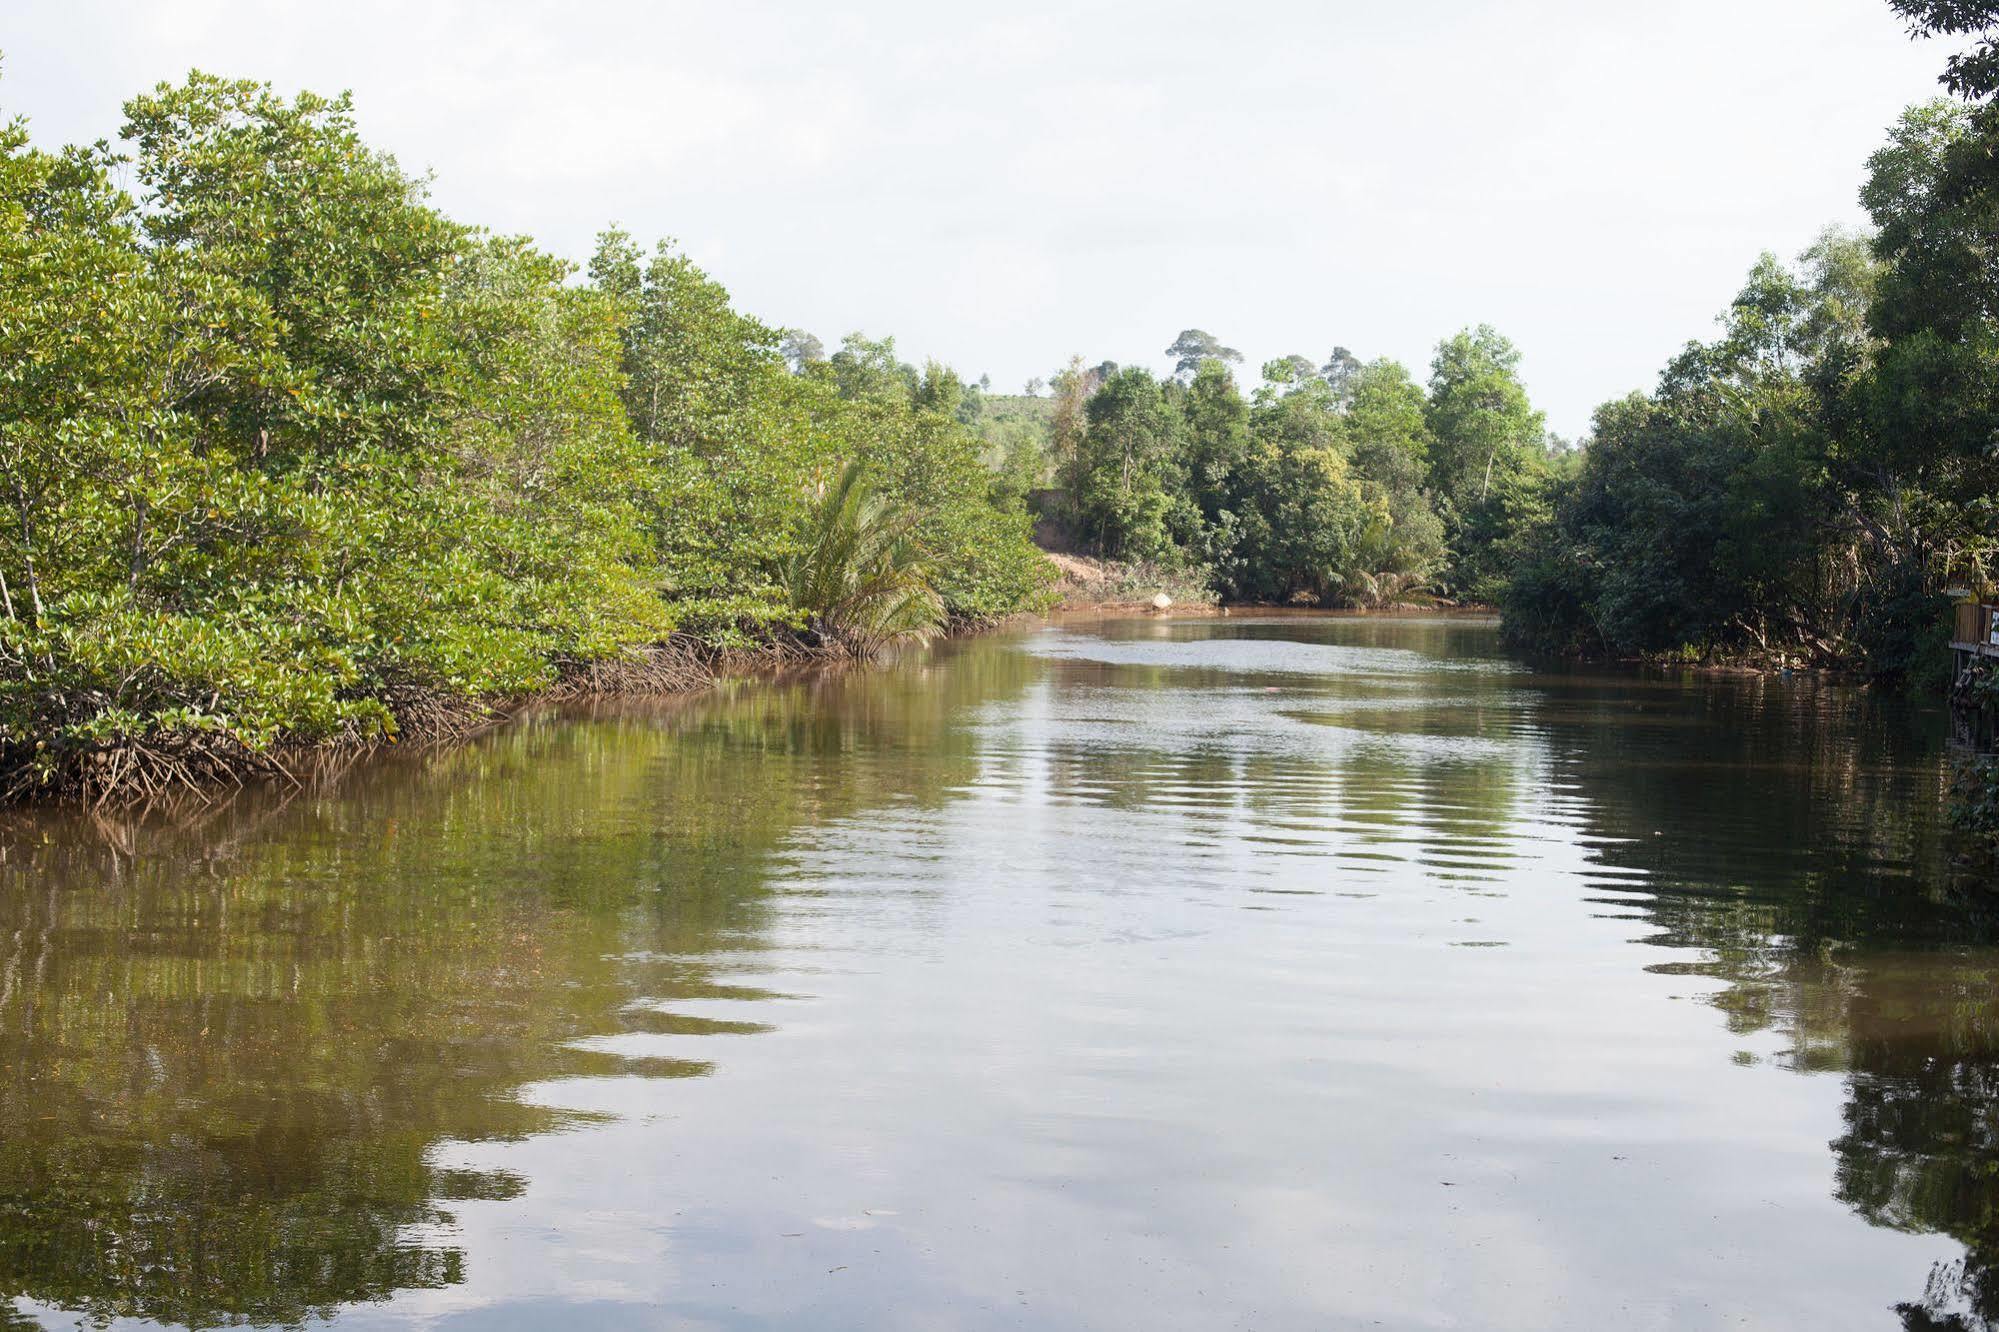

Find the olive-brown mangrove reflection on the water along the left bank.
xmin=0 ymin=640 xmax=1029 ymax=1326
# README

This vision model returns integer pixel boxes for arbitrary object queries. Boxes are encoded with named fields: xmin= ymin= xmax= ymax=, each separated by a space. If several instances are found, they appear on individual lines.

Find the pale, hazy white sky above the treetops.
xmin=0 ymin=0 xmax=1949 ymax=436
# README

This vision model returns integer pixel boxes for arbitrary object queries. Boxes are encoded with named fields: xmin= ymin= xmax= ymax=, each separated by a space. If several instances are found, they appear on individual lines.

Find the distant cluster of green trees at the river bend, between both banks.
xmin=1049 ymin=328 xmax=1561 ymax=606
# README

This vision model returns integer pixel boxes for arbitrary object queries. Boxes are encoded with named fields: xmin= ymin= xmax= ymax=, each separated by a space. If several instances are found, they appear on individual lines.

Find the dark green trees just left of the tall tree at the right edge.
xmin=1505 ymin=236 xmax=1871 ymax=660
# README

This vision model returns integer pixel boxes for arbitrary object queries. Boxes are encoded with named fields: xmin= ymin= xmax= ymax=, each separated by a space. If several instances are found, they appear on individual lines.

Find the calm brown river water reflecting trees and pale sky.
xmin=0 ymin=616 xmax=1999 ymax=1332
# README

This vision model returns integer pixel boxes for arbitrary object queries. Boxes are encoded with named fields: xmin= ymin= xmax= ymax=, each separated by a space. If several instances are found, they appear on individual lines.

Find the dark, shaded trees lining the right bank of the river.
xmin=1503 ymin=0 xmax=1999 ymax=690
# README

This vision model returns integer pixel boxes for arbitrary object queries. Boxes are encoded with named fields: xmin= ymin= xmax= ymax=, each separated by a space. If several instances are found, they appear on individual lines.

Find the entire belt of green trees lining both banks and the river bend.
xmin=11 ymin=0 xmax=1999 ymax=798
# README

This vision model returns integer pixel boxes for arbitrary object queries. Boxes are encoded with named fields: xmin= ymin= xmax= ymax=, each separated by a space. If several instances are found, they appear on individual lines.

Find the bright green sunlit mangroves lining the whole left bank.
xmin=0 ymin=76 xmax=1047 ymax=796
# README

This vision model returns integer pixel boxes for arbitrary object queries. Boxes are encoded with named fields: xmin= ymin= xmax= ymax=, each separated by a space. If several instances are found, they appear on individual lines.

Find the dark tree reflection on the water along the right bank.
xmin=1547 ymin=680 xmax=1999 ymax=1330
